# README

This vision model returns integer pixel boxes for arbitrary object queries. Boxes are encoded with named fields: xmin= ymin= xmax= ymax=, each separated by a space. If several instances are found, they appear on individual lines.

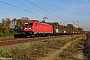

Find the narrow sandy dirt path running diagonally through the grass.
xmin=38 ymin=35 xmax=84 ymax=60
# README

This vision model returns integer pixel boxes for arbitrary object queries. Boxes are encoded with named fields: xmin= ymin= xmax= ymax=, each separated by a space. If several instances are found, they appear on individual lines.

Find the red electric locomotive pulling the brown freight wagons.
xmin=15 ymin=20 xmax=53 ymax=37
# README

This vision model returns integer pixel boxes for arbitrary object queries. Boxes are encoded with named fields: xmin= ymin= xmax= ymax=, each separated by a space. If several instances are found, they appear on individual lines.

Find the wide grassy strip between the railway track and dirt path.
xmin=0 ymin=35 xmax=80 ymax=60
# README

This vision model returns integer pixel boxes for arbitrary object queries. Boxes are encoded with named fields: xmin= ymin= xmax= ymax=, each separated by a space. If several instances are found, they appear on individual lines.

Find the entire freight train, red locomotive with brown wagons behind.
xmin=14 ymin=20 xmax=83 ymax=38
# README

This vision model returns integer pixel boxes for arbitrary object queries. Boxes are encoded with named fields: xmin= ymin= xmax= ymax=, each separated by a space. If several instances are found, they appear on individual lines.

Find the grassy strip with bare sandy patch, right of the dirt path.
xmin=54 ymin=37 xmax=86 ymax=60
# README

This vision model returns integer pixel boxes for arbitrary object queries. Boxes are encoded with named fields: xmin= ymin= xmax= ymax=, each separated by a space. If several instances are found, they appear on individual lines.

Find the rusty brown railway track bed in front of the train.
xmin=0 ymin=35 xmax=68 ymax=46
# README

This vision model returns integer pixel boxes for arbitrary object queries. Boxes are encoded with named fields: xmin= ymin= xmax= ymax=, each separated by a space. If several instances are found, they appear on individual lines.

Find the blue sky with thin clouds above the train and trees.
xmin=0 ymin=0 xmax=90 ymax=31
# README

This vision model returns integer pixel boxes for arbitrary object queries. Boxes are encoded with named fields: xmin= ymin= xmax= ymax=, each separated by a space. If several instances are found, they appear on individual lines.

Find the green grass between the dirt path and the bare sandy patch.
xmin=54 ymin=37 xmax=85 ymax=60
